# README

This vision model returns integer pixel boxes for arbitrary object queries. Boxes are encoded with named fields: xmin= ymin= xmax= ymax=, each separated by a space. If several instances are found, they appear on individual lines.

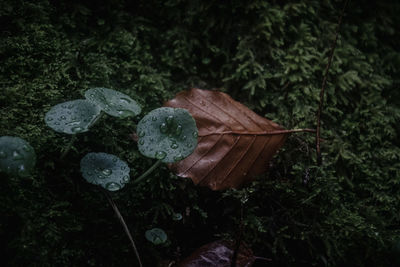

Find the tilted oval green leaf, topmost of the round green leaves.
xmin=85 ymin=88 xmax=141 ymax=118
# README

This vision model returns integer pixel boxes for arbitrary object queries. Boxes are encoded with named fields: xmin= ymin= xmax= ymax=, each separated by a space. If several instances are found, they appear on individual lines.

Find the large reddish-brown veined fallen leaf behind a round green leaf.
xmin=165 ymin=89 xmax=291 ymax=190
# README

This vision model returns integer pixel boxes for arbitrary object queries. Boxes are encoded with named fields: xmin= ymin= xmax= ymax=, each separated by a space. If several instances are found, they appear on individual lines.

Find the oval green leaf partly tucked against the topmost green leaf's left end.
xmin=44 ymin=99 xmax=101 ymax=134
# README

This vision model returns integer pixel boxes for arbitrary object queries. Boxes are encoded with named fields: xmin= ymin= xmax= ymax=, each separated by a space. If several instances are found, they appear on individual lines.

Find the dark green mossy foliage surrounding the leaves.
xmin=0 ymin=0 xmax=400 ymax=266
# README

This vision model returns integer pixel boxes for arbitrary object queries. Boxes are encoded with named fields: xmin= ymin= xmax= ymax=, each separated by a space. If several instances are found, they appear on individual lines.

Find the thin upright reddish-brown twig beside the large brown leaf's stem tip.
xmin=316 ymin=0 xmax=349 ymax=165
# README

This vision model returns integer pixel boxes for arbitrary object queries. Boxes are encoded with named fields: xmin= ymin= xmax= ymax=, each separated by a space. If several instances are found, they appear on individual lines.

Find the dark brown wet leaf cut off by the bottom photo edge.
xmin=178 ymin=240 xmax=256 ymax=267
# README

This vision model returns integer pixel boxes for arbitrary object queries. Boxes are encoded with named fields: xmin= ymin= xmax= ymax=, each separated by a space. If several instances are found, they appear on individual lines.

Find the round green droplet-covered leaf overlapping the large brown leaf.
xmin=137 ymin=107 xmax=198 ymax=163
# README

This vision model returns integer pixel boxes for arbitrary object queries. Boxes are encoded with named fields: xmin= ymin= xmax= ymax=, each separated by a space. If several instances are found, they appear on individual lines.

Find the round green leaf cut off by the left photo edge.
xmin=0 ymin=136 xmax=36 ymax=176
